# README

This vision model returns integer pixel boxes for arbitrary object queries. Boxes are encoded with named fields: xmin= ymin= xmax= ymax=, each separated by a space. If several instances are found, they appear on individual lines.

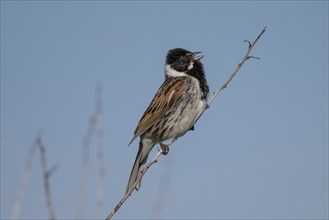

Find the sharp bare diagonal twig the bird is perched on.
xmin=106 ymin=27 xmax=266 ymax=220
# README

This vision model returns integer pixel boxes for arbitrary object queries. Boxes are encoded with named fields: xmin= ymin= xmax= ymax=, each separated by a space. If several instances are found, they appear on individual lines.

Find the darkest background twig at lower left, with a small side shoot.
xmin=37 ymin=137 xmax=56 ymax=220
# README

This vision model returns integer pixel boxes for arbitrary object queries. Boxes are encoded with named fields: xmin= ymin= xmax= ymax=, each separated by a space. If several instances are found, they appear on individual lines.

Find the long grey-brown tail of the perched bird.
xmin=126 ymin=138 xmax=154 ymax=194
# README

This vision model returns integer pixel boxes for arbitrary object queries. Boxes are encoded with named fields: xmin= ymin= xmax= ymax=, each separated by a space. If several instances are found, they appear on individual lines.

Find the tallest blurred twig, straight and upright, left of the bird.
xmin=95 ymin=86 xmax=105 ymax=218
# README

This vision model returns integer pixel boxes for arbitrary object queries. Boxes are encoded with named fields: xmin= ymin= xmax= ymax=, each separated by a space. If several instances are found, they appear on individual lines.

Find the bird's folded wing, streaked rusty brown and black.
xmin=129 ymin=77 xmax=185 ymax=145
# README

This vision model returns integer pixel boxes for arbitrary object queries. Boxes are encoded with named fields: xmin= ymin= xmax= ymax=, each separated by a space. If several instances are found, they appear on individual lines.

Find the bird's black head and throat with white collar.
xmin=166 ymin=48 xmax=209 ymax=97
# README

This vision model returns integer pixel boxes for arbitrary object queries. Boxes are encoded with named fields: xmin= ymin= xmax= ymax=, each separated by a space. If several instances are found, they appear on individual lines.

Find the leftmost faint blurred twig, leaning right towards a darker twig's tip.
xmin=11 ymin=140 xmax=37 ymax=219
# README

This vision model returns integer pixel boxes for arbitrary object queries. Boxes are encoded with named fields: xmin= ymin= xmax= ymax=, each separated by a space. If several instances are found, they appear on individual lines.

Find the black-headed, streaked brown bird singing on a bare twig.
xmin=126 ymin=48 xmax=209 ymax=194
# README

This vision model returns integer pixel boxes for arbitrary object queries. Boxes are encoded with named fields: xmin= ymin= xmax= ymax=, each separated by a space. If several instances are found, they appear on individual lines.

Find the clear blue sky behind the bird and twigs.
xmin=1 ymin=1 xmax=328 ymax=219
